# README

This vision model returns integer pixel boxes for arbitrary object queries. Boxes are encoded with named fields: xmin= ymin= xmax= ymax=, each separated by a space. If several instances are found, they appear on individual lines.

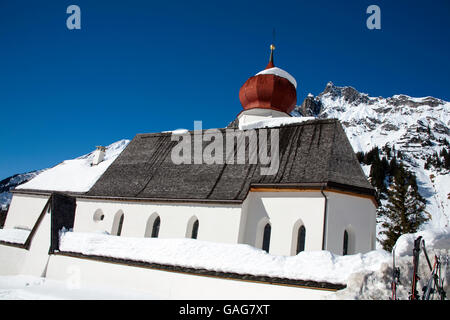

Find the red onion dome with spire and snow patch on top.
xmin=239 ymin=45 xmax=297 ymax=114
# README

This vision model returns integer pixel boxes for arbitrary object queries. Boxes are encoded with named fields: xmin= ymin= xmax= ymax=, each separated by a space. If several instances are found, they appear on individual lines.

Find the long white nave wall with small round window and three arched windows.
xmin=74 ymin=198 xmax=241 ymax=243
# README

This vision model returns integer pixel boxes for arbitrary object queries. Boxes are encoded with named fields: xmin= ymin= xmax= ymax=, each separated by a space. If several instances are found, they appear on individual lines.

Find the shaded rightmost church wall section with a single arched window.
xmin=325 ymin=192 xmax=376 ymax=254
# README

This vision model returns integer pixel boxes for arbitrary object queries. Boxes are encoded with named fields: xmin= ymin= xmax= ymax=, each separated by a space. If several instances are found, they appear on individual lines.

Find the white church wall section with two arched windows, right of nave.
xmin=242 ymin=192 xmax=325 ymax=256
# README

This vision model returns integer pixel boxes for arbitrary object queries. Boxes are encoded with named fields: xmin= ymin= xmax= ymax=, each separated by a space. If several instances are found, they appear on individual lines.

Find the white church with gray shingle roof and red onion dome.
xmin=0 ymin=46 xmax=377 ymax=300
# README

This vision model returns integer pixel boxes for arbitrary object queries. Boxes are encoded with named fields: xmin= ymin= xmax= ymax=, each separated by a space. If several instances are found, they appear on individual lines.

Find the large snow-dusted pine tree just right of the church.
xmin=380 ymin=164 xmax=428 ymax=251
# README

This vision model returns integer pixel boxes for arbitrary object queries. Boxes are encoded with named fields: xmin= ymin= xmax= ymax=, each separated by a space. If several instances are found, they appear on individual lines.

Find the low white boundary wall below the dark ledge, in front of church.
xmin=47 ymin=255 xmax=333 ymax=300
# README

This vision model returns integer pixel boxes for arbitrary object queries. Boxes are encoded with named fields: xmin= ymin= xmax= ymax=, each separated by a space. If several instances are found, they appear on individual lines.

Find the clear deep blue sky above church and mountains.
xmin=0 ymin=0 xmax=450 ymax=180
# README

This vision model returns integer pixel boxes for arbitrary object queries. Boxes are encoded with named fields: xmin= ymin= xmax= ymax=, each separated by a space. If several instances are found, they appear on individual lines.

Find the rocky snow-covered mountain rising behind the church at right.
xmin=292 ymin=82 xmax=450 ymax=228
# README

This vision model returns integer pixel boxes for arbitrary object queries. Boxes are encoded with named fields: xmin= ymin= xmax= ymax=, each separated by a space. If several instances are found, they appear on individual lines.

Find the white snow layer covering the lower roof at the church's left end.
xmin=16 ymin=139 xmax=130 ymax=192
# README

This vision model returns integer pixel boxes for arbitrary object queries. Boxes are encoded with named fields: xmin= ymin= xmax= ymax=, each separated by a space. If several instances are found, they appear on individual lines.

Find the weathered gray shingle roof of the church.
xmin=87 ymin=119 xmax=374 ymax=202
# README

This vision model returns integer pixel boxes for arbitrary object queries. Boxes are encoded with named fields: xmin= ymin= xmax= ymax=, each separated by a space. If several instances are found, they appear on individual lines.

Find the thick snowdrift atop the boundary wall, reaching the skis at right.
xmin=60 ymin=229 xmax=450 ymax=300
